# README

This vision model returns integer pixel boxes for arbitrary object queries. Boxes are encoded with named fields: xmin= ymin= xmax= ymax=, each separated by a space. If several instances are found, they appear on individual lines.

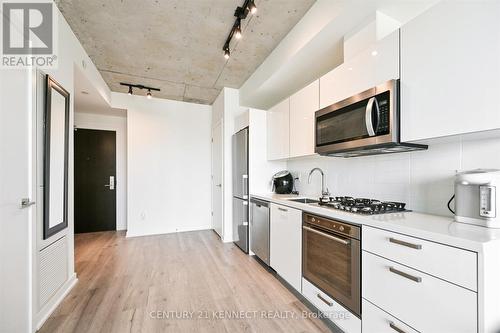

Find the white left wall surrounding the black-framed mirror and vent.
xmin=26 ymin=6 xmax=110 ymax=330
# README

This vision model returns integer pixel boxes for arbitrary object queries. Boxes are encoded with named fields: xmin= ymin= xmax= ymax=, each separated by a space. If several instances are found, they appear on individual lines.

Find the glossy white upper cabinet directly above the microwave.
xmin=320 ymin=30 xmax=399 ymax=108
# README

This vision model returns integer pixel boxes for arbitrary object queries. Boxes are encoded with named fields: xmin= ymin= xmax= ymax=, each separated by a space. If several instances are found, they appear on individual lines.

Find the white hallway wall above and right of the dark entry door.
xmin=75 ymin=110 xmax=127 ymax=230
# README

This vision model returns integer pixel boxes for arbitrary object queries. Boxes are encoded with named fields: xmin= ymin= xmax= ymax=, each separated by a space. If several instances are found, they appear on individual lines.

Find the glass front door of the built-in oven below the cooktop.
xmin=302 ymin=224 xmax=361 ymax=318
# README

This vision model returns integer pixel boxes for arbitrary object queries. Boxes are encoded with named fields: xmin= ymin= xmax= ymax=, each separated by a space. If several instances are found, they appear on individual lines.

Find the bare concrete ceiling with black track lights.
xmin=56 ymin=0 xmax=315 ymax=104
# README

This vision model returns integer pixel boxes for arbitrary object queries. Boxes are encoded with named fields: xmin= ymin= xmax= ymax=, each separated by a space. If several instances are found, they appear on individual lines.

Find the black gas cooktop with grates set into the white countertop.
xmin=318 ymin=197 xmax=408 ymax=215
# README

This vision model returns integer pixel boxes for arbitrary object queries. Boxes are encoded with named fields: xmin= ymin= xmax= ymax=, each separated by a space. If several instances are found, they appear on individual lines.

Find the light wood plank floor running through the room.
xmin=40 ymin=231 xmax=330 ymax=333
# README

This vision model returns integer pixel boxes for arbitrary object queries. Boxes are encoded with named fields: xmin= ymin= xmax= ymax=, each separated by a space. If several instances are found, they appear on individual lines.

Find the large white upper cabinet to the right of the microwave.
xmin=401 ymin=1 xmax=500 ymax=141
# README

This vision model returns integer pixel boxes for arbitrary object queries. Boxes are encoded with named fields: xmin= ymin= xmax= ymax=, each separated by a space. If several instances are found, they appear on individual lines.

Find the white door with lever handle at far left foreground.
xmin=0 ymin=69 xmax=32 ymax=332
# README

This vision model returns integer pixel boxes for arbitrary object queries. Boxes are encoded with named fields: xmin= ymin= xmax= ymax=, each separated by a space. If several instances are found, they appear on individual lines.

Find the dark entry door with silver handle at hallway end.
xmin=75 ymin=129 xmax=116 ymax=233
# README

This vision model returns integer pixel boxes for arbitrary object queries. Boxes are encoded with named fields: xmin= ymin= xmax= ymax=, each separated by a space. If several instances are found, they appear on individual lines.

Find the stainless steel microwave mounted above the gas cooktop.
xmin=315 ymin=80 xmax=427 ymax=157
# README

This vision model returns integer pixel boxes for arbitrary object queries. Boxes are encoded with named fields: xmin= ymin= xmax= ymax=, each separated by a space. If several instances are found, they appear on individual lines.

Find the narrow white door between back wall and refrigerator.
xmin=212 ymin=121 xmax=224 ymax=238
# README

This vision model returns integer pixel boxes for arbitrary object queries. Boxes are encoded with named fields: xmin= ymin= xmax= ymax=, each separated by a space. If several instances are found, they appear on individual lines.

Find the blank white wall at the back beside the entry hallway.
xmin=112 ymin=93 xmax=212 ymax=237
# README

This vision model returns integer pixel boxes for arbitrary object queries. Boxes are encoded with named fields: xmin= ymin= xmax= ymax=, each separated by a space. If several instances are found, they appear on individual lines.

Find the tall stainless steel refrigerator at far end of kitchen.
xmin=233 ymin=127 xmax=249 ymax=253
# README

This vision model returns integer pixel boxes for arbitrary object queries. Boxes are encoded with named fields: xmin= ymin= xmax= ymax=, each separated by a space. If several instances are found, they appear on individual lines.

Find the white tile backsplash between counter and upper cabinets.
xmin=287 ymin=138 xmax=500 ymax=216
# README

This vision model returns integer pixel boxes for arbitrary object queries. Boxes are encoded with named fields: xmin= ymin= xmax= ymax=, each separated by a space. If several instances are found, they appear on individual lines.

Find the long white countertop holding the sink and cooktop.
xmin=251 ymin=193 xmax=500 ymax=252
